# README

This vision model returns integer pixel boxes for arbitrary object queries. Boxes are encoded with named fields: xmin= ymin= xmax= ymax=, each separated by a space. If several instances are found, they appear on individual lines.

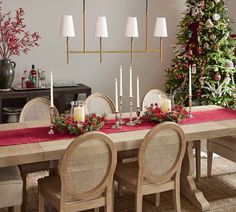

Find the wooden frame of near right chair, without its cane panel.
xmin=115 ymin=122 xmax=186 ymax=212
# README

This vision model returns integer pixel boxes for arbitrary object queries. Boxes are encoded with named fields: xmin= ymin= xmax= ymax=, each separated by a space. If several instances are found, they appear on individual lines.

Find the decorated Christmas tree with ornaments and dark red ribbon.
xmin=166 ymin=0 xmax=236 ymax=108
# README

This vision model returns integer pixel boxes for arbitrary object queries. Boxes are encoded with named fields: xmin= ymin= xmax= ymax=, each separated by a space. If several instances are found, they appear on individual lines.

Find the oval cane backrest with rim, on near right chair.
xmin=138 ymin=122 xmax=186 ymax=184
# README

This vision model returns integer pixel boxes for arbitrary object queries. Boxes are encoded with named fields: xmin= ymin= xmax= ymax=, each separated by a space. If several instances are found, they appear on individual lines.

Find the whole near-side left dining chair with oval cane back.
xmin=38 ymin=132 xmax=117 ymax=212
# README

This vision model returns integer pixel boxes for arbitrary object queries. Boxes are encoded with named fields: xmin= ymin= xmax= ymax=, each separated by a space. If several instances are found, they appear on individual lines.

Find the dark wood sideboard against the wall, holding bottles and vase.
xmin=0 ymin=84 xmax=91 ymax=123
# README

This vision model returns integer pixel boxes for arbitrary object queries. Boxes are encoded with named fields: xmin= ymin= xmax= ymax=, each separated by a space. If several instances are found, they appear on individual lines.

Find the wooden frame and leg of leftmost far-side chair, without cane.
xmin=19 ymin=97 xmax=59 ymax=211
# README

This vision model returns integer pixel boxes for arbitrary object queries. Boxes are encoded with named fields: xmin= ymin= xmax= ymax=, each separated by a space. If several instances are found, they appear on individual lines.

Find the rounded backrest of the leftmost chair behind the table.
xmin=20 ymin=97 xmax=59 ymax=122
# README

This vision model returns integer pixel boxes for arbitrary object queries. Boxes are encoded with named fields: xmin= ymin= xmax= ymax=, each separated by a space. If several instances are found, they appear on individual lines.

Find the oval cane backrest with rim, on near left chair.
xmin=60 ymin=132 xmax=117 ymax=201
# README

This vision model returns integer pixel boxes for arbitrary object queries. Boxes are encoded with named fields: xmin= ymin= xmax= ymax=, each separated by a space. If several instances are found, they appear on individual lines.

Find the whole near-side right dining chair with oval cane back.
xmin=114 ymin=122 xmax=186 ymax=212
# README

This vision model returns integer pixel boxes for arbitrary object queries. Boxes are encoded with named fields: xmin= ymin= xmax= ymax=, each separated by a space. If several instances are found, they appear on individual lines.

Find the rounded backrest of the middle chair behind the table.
xmin=85 ymin=93 xmax=115 ymax=114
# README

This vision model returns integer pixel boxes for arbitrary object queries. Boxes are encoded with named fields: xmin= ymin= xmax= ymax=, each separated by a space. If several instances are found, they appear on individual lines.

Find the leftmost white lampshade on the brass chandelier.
xmin=60 ymin=15 xmax=75 ymax=37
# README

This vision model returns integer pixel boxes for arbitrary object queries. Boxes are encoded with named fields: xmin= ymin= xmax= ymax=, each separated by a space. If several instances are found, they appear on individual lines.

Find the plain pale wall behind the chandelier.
xmin=3 ymin=0 xmax=236 ymax=107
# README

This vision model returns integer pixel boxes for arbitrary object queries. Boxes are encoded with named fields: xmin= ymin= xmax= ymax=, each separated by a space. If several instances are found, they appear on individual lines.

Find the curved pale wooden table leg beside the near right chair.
xmin=180 ymin=142 xmax=209 ymax=211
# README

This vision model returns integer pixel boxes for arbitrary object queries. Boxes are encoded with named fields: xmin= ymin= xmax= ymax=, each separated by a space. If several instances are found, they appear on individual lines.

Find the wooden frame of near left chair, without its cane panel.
xmin=39 ymin=132 xmax=117 ymax=212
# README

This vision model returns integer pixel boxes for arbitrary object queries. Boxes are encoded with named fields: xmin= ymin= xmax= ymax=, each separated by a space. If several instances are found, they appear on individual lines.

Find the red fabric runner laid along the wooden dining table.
xmin=0 ymin=109 xmax=236 ymax=146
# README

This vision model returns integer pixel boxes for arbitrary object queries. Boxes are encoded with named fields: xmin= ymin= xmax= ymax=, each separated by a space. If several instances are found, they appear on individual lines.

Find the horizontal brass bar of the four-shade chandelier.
xmin=69 ymin=49 xmax=161 ymax=54
